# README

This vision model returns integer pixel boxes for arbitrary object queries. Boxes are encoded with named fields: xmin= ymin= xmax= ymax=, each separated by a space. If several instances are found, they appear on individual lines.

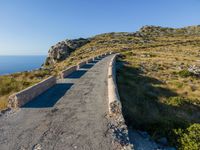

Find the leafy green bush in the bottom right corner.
xmin=175 ymin=123 xmax=200 ymax=150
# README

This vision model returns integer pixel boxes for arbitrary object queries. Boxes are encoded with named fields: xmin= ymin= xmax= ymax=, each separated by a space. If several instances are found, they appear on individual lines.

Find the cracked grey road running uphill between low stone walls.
xmin=0 ymin=55 xmax=114 ymax=150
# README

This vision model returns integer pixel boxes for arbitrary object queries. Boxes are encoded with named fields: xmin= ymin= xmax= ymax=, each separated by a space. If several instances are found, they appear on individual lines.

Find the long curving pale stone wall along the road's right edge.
xmin=108 ymin=54 xmax=133 ymax=150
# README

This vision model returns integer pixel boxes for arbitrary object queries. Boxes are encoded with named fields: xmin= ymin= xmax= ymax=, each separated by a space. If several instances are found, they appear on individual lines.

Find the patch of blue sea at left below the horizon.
xmin=0 ymin=56 xmax=46 ymax=75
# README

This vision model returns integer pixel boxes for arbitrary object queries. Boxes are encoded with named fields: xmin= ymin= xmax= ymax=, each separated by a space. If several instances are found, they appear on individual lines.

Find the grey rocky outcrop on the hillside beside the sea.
xmin=45 ymin=38 xmax=89 ymax=65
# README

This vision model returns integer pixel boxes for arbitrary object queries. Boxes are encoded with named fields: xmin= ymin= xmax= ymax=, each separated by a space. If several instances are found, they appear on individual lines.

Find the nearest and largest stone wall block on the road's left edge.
xmin=8 ymin=76 xmax=56 ymax=108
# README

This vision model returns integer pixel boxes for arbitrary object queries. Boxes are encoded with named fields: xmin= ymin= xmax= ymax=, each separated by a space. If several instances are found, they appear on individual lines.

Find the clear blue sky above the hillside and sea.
xmin=0 ymin=0 xmax=200 ymax=55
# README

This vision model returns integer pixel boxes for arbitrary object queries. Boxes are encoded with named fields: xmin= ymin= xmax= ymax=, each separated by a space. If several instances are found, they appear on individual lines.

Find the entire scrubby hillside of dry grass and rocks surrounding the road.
xmin=0 ymin=26 xmax=200 ymax=149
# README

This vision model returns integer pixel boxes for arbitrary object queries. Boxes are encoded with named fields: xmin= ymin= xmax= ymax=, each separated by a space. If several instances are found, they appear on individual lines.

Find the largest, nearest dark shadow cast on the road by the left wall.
xmin=23 ymin=83 xmax=73 ymax=108
